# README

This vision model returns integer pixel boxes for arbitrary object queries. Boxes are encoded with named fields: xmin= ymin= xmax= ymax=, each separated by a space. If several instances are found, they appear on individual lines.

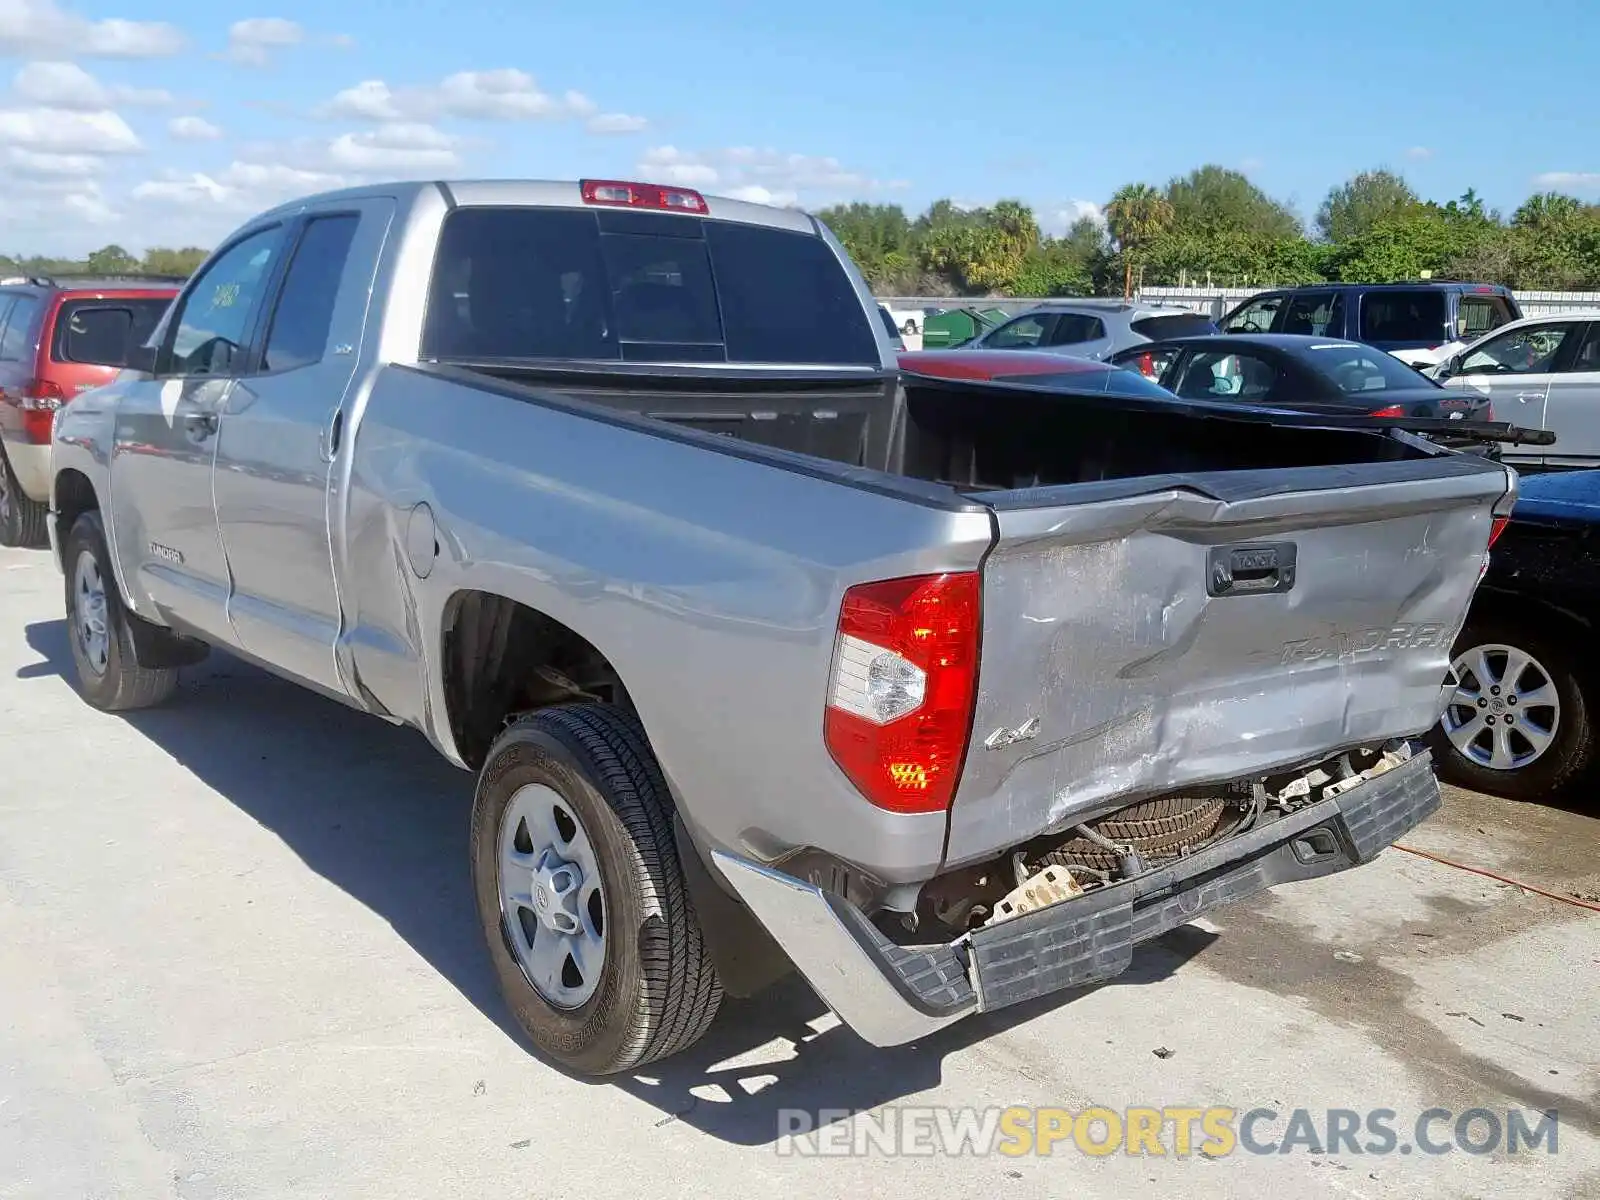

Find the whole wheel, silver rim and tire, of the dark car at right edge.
xmin=1429 ymin=616 xmax=1597 ymax=800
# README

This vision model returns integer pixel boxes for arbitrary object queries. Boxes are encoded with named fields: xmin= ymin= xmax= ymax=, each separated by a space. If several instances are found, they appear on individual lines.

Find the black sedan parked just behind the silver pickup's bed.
xmin=1110 ymin=333 xmax=1493 ymax=421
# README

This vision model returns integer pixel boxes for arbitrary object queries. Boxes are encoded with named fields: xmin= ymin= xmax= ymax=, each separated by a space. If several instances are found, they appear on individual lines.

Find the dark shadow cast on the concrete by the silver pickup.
xmin=18 ymin=621 xmax=1213 ymax=1144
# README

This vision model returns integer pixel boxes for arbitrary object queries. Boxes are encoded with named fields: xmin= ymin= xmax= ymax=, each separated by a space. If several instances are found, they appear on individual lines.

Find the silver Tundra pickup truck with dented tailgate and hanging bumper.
xmin=50 ymin=181 xmax=1515 ymax=1074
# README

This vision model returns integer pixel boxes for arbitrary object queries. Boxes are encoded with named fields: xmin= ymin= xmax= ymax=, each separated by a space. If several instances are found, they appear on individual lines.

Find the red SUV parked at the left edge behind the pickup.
xmin=0 ymin=275 xmax=182 ymax=546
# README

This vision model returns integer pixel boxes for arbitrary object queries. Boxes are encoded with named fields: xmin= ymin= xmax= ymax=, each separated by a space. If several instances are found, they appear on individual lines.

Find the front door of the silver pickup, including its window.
xmin=109 ymin=222 xmax=285 ymax=645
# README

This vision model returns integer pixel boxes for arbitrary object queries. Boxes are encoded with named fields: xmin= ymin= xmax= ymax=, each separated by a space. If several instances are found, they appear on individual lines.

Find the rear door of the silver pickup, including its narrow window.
xmin=216 ymin=198 xmax=394 ymax=696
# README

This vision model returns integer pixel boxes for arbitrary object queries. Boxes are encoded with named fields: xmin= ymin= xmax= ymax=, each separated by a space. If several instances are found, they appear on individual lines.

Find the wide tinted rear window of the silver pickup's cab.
xmin=422 ymin=208 xmax=878 ymax=365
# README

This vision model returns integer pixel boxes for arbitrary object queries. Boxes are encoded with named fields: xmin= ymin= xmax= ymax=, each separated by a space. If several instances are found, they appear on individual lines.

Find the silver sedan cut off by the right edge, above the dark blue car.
xmin=1432 ymin=309 xmax=1600 ymax=469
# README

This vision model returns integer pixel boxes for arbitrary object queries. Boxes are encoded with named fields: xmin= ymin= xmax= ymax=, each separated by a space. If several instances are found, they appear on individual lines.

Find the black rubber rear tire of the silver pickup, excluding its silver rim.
xmin=470 ymin=704 xmax=722 ymax=1075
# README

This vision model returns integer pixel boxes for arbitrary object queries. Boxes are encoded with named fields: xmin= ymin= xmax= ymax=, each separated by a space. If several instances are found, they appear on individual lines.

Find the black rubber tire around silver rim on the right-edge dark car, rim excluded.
xmin=1427 ymin=610 xmax=1600 ymax=802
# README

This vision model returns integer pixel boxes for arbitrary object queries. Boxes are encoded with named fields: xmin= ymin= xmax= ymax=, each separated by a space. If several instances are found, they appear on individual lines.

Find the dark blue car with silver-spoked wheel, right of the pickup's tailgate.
xmin=1429 ymin=470 xmax=1600 ymax=802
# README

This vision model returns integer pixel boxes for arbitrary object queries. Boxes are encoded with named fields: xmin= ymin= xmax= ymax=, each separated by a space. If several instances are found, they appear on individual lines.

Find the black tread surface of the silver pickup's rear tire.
xmin=491 ymin=704 xmax=722 ymax=1074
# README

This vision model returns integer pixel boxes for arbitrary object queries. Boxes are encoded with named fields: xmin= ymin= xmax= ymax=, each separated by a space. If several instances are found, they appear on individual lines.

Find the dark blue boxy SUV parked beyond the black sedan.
xmin=1221 ymin=283 xmax=1522 ymax=366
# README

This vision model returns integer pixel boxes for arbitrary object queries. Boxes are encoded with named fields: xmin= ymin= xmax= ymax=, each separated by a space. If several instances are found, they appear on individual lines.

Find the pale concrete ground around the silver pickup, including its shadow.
xmin=0 ymin=550 xmax=1600 ymax=1200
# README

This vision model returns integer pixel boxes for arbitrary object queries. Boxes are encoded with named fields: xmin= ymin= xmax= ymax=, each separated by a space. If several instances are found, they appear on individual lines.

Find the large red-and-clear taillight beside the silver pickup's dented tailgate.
xmin=822 ymin=571 xmax=981 ymax=813
